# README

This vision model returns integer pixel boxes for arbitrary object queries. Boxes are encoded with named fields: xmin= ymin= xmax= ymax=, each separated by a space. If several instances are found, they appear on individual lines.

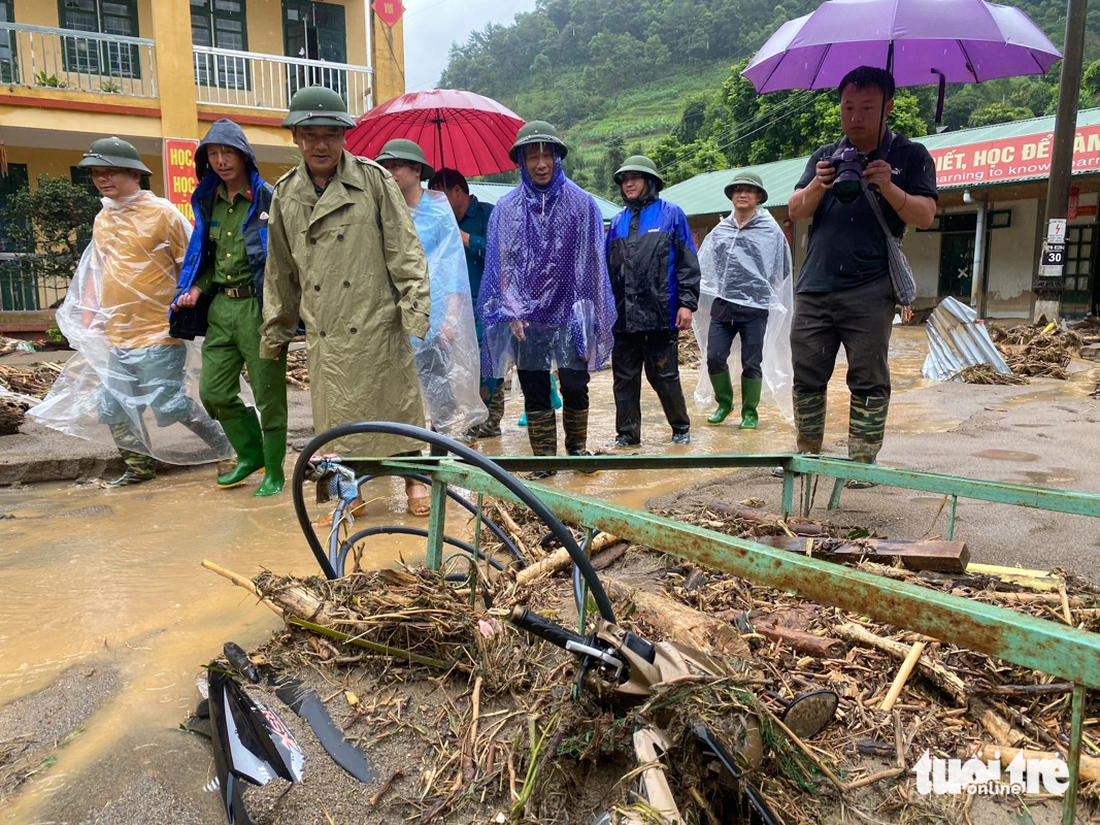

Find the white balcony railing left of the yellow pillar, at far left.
xmin=0 ymin=23 xmax=157 ymax=98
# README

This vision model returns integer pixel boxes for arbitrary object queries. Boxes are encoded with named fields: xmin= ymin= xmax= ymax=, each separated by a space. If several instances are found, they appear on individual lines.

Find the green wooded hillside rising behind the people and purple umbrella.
xmin=439 ymin=0 xmax=1100 ymax=197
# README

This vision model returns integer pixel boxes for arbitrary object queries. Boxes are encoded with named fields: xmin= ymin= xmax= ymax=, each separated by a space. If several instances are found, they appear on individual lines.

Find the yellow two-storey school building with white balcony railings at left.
xmin=0 ymin=0 xmax=405 ymax=310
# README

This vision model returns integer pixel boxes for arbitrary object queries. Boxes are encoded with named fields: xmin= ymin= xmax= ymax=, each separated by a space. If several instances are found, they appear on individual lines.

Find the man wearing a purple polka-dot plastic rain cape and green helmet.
xmin=479 ymin=121 xmax=615 ymax=477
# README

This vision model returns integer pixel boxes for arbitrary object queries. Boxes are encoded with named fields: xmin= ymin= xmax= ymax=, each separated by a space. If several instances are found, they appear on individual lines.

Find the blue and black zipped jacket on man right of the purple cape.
xmin=605 ymin=197 xmax=700 ymax=332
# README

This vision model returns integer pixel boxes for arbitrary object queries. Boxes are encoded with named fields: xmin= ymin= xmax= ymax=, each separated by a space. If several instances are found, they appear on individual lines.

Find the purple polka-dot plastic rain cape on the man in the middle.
xmin=479 ymin=157 xmax=616 ymax=378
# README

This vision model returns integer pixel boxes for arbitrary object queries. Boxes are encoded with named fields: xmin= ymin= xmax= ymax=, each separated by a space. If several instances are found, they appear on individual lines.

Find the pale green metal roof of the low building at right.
xmin=661 ymin=108 xmax=1100 ymax=218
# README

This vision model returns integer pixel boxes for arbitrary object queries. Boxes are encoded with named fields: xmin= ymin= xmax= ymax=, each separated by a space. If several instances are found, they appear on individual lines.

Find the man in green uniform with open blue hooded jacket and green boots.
xmin=171 ymin=120 xmax=287 ymax=496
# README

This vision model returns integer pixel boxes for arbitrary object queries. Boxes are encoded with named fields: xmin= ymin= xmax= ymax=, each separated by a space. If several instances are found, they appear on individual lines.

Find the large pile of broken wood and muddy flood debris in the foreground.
xmin=204 ymin=501 xmax=1100 ymax=825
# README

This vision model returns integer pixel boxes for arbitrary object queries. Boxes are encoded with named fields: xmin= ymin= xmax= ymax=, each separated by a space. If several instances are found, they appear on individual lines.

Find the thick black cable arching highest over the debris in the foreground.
xmin=290 ymin=421 xmax=615 ymax=624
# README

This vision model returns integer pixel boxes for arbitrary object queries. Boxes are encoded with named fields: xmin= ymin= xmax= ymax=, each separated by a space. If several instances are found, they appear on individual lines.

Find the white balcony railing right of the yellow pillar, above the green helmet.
xmin=194 ymin=46 xmax=372 ymax=118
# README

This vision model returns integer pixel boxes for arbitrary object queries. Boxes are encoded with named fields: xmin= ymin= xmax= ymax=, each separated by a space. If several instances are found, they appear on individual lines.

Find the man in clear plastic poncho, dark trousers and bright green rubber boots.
xmin=695 ymin=172 xmax=792 ymax=430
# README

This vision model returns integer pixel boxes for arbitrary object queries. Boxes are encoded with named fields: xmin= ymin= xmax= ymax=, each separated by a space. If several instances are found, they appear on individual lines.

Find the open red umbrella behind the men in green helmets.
xmin=347 ymin=89 xmax=524 ymax=177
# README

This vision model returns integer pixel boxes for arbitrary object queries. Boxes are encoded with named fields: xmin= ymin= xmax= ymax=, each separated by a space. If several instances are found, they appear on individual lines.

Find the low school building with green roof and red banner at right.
xmin=662 ymin=109 xmax=1100 ymax=318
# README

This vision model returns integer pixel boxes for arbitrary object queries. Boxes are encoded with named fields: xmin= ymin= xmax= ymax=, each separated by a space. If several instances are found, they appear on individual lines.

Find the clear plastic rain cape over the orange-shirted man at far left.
xmin=30 ymin=191 xmax=233 ymax=464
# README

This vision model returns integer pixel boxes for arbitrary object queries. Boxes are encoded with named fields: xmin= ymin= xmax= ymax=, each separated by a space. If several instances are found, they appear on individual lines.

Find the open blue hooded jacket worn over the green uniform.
xmin=168 ymin=119 xmax=272 ymax=340
